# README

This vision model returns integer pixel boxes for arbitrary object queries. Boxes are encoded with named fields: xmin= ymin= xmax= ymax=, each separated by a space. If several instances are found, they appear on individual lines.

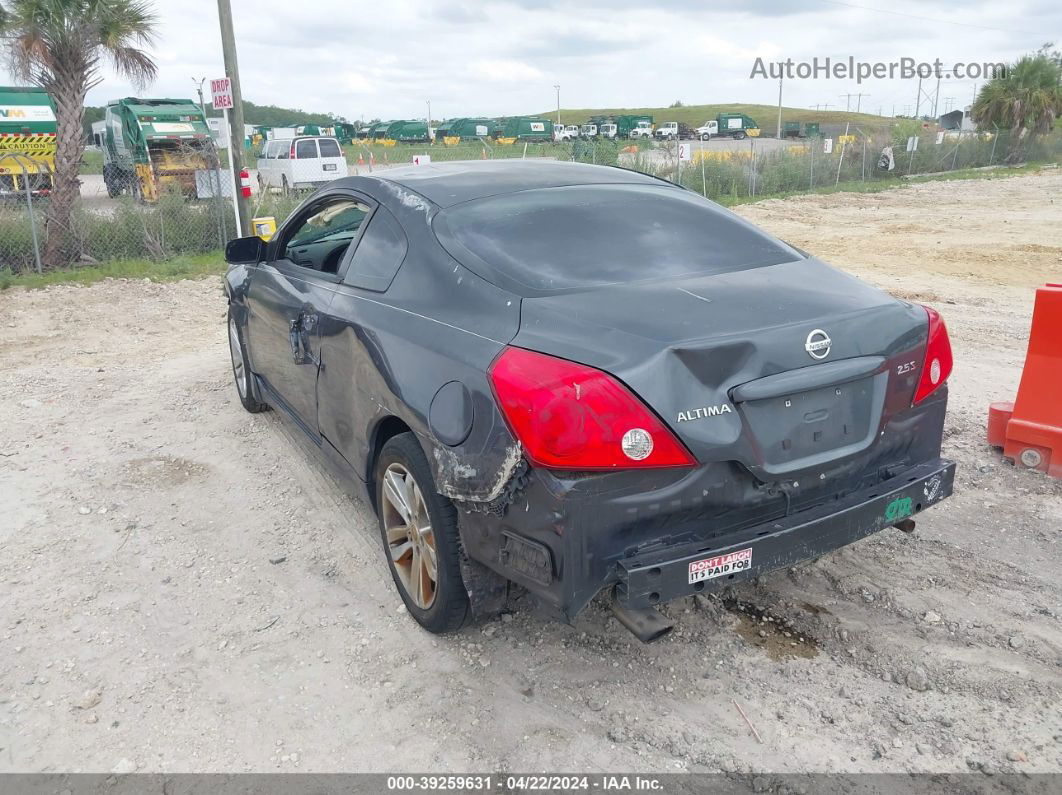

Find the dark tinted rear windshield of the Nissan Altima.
xmin=434 ymin=185 xmax=802 ymax=292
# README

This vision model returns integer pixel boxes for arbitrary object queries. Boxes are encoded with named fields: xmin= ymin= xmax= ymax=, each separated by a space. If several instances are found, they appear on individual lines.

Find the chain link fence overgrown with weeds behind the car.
xmin=0 ymin=128 xmax=1062 ymax=274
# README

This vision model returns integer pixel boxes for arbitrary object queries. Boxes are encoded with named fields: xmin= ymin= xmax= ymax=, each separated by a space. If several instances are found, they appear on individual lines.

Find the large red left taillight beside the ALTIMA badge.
xmin=491 ymin=348 xmax=697 ymax=469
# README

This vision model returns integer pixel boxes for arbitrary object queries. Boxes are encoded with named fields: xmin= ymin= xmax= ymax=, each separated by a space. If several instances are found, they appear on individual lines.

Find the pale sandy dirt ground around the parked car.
xmin=0 ymin=171 xmax=1062 ymax=777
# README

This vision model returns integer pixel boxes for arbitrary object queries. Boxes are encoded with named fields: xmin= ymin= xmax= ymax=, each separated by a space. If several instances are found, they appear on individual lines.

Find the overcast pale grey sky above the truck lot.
xmin=0 ymin=0 xmax=1062 ymax=119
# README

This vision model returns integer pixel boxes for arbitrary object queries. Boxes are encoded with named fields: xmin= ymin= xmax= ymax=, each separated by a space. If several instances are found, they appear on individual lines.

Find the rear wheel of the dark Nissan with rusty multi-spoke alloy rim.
xmin=376 ymin=433 xmax=472 ymax=633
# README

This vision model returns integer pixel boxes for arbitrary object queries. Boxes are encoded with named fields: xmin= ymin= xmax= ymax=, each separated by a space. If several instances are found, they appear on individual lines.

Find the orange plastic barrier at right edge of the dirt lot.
xmin=988 ymin=284 xmax=1062 ymax=479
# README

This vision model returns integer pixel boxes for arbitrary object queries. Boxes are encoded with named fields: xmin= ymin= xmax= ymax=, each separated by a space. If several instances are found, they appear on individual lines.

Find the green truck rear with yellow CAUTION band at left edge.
xmin=0 ymin=86 xmax=55 ymax=195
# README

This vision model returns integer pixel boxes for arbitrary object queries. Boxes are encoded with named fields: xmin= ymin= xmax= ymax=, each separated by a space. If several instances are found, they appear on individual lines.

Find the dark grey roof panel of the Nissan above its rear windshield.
xmin=340 ymin=158 xmax=668 ymax=207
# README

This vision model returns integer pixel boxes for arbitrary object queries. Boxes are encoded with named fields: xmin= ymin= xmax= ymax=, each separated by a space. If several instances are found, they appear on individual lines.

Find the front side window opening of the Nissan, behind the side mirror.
xmin=281 ymin=197 xmax=372 ymax=274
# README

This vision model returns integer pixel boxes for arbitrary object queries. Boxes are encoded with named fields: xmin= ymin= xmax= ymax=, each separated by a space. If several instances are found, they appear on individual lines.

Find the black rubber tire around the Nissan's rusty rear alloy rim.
xmin=375 ymin=433 xmax=472 ymax=634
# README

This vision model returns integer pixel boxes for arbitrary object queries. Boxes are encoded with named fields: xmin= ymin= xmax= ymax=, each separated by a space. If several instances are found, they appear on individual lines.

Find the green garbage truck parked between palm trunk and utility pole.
xmin=103 ymin=97 xmax=217 ymax=202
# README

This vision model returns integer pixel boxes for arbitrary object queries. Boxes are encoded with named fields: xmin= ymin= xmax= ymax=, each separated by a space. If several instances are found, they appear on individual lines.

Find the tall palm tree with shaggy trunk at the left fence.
xmin=0 ymin=0 xmax=156 ymax=267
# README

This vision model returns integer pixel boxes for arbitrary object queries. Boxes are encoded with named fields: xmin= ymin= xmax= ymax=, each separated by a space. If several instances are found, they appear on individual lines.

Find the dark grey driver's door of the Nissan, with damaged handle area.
xmin=247 ymin=192 xmax=372 ymax=437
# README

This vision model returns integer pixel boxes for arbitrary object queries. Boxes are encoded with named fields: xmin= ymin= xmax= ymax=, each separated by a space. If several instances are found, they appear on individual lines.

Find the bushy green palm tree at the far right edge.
xmin=971 ymin=51 xmax=1062 ymax=161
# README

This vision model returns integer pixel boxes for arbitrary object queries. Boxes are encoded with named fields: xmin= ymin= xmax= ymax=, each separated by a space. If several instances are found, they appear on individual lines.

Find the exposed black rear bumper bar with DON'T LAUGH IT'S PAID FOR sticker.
xmin=616 ymin=459 xmax=955 ymax=608
